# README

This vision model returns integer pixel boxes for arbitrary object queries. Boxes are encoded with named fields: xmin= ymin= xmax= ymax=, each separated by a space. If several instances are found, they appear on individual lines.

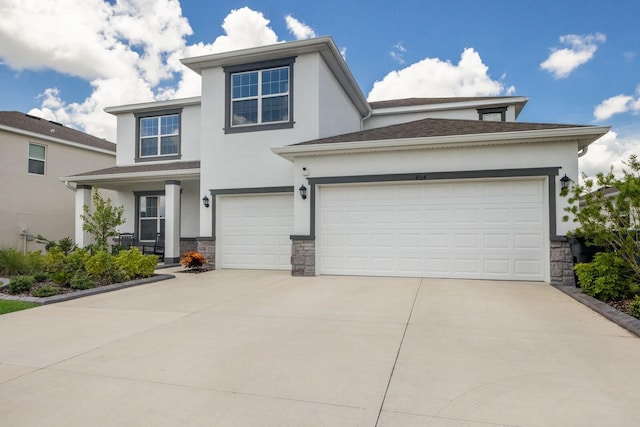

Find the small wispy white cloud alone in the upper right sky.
xmin=540 ymin=33 xmax=607 ymax=79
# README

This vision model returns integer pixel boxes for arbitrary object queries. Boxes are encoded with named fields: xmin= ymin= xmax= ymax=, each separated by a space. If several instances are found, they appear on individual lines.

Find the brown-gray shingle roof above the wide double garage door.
xmin=293 ymin=119 xmax=587 ymax=145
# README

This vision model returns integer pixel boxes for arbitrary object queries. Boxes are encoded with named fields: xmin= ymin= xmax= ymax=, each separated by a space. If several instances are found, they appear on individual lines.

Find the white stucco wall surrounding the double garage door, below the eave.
xmin=294 ymin=142 xmax=578 ymax=235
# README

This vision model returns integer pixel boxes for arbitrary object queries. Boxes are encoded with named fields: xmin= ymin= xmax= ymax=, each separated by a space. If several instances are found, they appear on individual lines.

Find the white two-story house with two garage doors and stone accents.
xmin=67 ymin=37 xmax=608 ymax=282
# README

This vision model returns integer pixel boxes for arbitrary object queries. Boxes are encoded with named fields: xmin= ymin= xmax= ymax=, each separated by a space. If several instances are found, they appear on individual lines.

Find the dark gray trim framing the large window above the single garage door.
xmin=223 ymin=56 xmax=296 ymax=134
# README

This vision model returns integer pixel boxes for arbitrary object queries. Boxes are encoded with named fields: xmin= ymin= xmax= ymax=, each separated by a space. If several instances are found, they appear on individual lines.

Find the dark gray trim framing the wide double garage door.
xmin=300 ymin=166 xmax=561 ymax=240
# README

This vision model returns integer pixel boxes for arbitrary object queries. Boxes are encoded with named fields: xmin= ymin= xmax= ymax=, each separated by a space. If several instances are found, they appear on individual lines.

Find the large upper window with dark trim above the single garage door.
xmin=225 ymin=58 xmax=294 ymax=133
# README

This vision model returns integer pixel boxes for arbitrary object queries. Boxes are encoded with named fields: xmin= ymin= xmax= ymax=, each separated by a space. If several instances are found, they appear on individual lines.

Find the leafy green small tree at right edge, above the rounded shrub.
xmin=562 ymin=154 xmax=640 ymax=277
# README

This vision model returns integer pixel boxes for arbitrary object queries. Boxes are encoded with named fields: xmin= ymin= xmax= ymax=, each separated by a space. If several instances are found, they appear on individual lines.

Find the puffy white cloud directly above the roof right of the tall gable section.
xmin=368 ymin=48 xmax=508 ymax=101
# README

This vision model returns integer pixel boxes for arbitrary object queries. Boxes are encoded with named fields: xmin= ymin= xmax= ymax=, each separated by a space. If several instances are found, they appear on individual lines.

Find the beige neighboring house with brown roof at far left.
xmin=0 ymin=111 xmax=116 ymax=250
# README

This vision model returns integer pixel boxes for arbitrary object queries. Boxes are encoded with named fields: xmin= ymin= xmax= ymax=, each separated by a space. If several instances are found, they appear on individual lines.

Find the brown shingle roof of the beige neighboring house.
xmin=0 ymin=111 xmax=116 ymax=153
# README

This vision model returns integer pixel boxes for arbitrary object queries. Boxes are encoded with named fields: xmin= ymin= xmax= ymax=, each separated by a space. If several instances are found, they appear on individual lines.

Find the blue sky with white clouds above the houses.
xmin=0 ymin=0 xmax=640 ymax=176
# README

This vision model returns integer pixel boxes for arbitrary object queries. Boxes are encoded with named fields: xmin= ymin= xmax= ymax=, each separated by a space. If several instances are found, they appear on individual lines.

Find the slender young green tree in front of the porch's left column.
xmin=80 ymin=188 xmax=125 ymax=251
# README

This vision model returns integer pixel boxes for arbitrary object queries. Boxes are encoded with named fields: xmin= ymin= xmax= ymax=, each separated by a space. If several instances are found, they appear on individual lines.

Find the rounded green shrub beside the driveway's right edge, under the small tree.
xmin=574 ymin=252 xmax=638 ymax=301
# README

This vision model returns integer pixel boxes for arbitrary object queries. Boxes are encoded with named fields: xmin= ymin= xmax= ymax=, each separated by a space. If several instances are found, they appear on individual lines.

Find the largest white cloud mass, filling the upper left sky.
xmin=0 ymin=0 xmax=278 ymax=141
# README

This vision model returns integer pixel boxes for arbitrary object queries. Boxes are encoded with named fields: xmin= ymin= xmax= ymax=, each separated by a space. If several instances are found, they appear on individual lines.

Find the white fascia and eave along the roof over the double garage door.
xmin=271 ymin=126 xmax=610 ymax=161
